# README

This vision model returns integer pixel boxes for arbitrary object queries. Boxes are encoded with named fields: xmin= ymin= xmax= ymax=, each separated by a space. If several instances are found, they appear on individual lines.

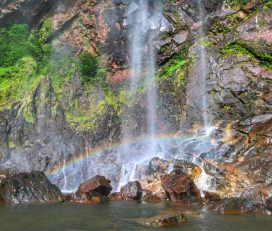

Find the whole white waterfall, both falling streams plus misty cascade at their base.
xmin=50 ymin=0 xmax=218 ymax=191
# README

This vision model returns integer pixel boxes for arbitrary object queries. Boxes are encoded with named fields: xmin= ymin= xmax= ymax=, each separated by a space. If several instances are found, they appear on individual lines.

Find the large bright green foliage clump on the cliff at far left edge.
xmin=0 ymin=21 xmax=54 ymax=114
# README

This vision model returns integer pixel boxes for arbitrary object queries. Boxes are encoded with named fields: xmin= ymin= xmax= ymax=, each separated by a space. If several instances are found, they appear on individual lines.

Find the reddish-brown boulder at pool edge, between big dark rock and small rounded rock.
xmin=77 ymin=176 xmax=112 ymax=196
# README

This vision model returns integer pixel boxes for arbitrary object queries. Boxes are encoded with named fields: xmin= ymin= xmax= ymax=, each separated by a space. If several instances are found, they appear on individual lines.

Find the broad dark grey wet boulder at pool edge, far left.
xmin=0 ymin=171 xmax=62 ymax=204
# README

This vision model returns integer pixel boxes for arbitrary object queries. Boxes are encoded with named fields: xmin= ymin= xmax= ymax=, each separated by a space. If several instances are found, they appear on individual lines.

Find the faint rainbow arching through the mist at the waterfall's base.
xmin=48 ymin=134 xmax=208 ymax=178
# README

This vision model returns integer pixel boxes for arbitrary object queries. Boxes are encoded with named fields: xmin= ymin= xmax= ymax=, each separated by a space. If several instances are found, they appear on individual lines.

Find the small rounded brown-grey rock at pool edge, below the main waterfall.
xmin=120 ymin=181 xmax=142 ymax=200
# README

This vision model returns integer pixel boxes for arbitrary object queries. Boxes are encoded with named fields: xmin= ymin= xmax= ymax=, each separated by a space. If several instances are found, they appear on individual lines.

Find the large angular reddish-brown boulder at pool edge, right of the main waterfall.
xmin=161 ymin=170 xmax=201 ymax=201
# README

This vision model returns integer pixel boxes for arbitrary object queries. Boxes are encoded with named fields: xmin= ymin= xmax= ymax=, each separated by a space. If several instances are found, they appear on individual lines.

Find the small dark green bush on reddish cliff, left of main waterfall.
xmin=79 ymin=52 xmax=98 ymax=83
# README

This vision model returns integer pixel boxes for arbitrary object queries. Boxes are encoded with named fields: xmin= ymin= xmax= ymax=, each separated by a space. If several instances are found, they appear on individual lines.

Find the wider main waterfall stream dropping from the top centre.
xmin=123 ymin=0 xmax=163 ymax=155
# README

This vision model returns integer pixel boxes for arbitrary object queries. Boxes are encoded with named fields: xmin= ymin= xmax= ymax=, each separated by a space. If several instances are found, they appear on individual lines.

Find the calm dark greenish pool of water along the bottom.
xmin=0 ymin=202 xmax=272 ymax=231
